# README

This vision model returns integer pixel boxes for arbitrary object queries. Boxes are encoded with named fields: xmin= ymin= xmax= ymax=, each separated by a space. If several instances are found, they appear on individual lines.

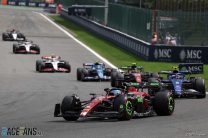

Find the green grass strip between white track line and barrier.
xmin=50 ymin=15 xmax=208 ymax=89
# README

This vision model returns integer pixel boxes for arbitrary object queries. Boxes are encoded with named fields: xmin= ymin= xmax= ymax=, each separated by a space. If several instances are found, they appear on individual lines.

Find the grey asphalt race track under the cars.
xmin=0 ymin=9 xmax=208 ymax=138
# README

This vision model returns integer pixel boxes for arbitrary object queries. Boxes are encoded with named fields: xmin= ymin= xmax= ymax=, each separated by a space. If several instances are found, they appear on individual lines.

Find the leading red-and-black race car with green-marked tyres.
xmin=54 ymin=82 xmax=175 ymax=121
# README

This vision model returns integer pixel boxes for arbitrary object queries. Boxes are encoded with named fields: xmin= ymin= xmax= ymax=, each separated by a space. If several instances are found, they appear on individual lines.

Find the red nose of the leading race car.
xmin=80 ymin=96 xmax=115 ymax=117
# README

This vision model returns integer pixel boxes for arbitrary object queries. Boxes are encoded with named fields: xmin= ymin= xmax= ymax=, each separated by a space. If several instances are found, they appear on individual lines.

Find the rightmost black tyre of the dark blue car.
xmin=194 ymin=78 xmax=206 ymax=98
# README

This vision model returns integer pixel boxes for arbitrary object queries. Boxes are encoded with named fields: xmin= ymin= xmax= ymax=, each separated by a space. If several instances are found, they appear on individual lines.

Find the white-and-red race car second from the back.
xmin=13 ymin=41 xmax=40 ymax=54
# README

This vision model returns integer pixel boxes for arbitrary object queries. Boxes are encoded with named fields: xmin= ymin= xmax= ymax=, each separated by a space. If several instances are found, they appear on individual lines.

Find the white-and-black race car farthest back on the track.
xmin=2 ymin=29 xmax=25 ymax=41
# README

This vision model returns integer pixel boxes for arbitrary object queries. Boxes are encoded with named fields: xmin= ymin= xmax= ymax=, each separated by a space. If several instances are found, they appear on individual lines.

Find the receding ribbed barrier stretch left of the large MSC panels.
xmin=61 ymin=9 xmax=150 ymax=60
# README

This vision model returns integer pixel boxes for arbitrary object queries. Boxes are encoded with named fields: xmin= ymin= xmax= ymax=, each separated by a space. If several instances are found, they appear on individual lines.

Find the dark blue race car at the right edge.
xmin=159 ymin=67 xmax=206 ymax=98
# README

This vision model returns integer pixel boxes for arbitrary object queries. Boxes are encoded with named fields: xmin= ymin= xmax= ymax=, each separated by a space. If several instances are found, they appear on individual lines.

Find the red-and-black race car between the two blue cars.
xmin=111 ymin=63 xmax=159 ymax=87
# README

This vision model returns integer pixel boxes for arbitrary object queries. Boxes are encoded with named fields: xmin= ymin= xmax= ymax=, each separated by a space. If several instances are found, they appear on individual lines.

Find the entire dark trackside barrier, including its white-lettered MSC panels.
xmin=61 ymin=9 xmax=208 ymax=64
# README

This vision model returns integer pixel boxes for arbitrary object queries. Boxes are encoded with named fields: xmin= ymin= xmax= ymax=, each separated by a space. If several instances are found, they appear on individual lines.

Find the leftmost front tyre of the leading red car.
xmin=61 ymin=96 xmax=81 ymax=121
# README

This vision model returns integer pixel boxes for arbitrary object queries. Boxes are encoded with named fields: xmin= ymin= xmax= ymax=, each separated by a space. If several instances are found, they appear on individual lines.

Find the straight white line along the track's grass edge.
xmin=36 ymin=12 xmax=117 ymax=68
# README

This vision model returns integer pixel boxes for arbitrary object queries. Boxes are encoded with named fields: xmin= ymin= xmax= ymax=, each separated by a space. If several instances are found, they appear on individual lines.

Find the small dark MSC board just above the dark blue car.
xmin=178 ymin=63 xmax=204 ymax=74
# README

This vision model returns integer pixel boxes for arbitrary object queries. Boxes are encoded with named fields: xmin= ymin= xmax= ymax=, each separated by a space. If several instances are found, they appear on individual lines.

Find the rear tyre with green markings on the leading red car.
xmin=153 ymin=90 xmax=175 ymax=116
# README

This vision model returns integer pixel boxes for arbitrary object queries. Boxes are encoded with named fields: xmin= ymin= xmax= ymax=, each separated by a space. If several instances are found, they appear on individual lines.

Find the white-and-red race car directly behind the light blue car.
xmin=36 ymin=56 xmax=71 ymax=73
